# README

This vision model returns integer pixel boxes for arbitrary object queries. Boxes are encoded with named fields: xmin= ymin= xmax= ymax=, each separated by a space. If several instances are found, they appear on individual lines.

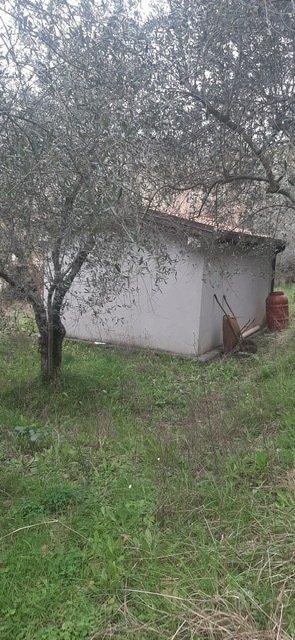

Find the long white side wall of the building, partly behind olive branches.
xmin=64 ymin=240 xmax=204 ymax=355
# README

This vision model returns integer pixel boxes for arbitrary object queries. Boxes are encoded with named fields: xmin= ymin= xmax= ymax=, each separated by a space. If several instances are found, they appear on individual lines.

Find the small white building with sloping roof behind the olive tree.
xmin=64 ymin=215 xmax=284 ymax=356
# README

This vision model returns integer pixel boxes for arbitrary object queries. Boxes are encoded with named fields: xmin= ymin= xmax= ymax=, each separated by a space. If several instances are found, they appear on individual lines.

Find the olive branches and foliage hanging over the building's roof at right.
xmin=145 ymin=0 xmax=295 ymax=231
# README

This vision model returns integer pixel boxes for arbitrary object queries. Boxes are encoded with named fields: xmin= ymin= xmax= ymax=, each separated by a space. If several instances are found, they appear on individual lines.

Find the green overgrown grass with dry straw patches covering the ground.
xmin=0 ymin=290 xmax=295 ymax=640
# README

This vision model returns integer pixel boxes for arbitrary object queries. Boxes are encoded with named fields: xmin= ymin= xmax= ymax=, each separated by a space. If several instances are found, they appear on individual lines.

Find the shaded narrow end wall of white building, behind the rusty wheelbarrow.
xmin=199 ymin=245 xmax=272 ymax=354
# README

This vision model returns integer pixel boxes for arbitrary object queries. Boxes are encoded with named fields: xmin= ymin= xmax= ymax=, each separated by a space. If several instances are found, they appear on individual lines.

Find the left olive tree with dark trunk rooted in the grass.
xmin=0 ymin=0 xmax=169 ymax=378
